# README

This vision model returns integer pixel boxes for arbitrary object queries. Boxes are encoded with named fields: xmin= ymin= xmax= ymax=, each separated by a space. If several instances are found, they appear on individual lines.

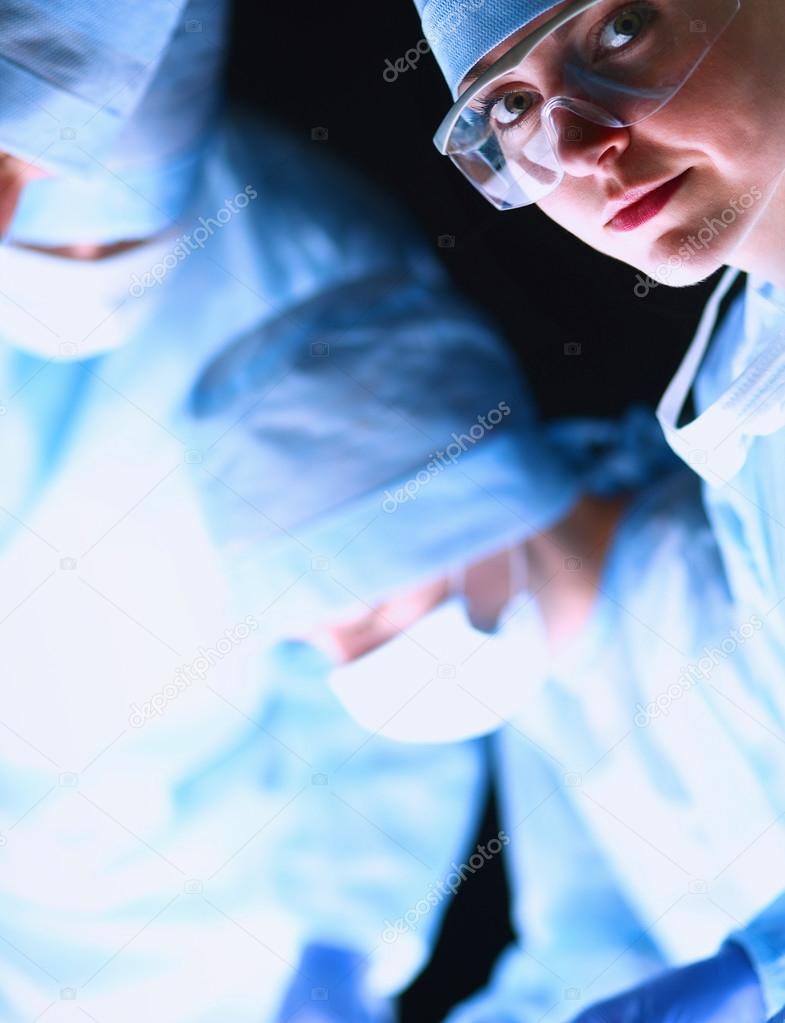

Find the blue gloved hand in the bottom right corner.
xmin=573 ymin=941 xmax=767 ymax=1023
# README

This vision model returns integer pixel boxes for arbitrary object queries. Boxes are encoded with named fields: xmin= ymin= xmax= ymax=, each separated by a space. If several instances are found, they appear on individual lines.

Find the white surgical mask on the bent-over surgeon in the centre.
xmin=330 ymin=552 xmax=547 ymax=743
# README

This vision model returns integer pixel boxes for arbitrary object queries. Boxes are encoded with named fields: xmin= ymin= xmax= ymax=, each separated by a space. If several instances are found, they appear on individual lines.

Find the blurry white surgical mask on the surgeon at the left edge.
xmin=0 ymin=232 xmax=181 ymax=361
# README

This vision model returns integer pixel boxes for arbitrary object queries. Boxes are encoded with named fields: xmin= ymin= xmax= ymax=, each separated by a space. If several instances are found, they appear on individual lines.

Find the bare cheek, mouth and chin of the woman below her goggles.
xmin=462 ymin=0 xmax=785 ymax=285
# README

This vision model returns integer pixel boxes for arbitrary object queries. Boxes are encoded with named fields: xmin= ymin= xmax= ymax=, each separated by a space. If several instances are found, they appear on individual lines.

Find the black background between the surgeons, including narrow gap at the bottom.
xmin=229 ymin=0 xmax=713 ymax=1023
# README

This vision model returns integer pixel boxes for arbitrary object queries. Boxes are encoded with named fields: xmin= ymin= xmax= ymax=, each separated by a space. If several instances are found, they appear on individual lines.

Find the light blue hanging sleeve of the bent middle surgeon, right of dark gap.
xmin=447 ymin=727 xmax=664 ymax=1023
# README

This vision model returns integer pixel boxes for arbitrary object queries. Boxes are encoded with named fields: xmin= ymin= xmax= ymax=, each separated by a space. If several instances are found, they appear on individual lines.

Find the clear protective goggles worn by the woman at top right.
xmin=434 ymin=0 xmax=741 ymax=210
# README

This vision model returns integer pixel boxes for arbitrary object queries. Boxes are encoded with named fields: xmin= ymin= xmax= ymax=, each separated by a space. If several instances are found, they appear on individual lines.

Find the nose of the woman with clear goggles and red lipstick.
xmin=543 ymin=104 xmax=629 ymax=178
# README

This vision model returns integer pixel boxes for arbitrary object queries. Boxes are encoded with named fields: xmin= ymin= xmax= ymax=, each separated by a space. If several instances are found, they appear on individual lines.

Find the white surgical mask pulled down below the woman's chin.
xmin=657 ymin=269 xmax=785 ymax=487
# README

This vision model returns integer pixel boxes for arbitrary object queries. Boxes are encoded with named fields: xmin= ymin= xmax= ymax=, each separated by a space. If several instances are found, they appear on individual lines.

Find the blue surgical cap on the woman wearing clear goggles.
xmin=415 ymin=0 xmax=561 ymax=96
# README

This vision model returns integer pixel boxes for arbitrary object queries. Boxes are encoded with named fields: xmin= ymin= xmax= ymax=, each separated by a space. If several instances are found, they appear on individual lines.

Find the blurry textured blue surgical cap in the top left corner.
xmin=0 ymin=0 xmax=186 ymax=173
